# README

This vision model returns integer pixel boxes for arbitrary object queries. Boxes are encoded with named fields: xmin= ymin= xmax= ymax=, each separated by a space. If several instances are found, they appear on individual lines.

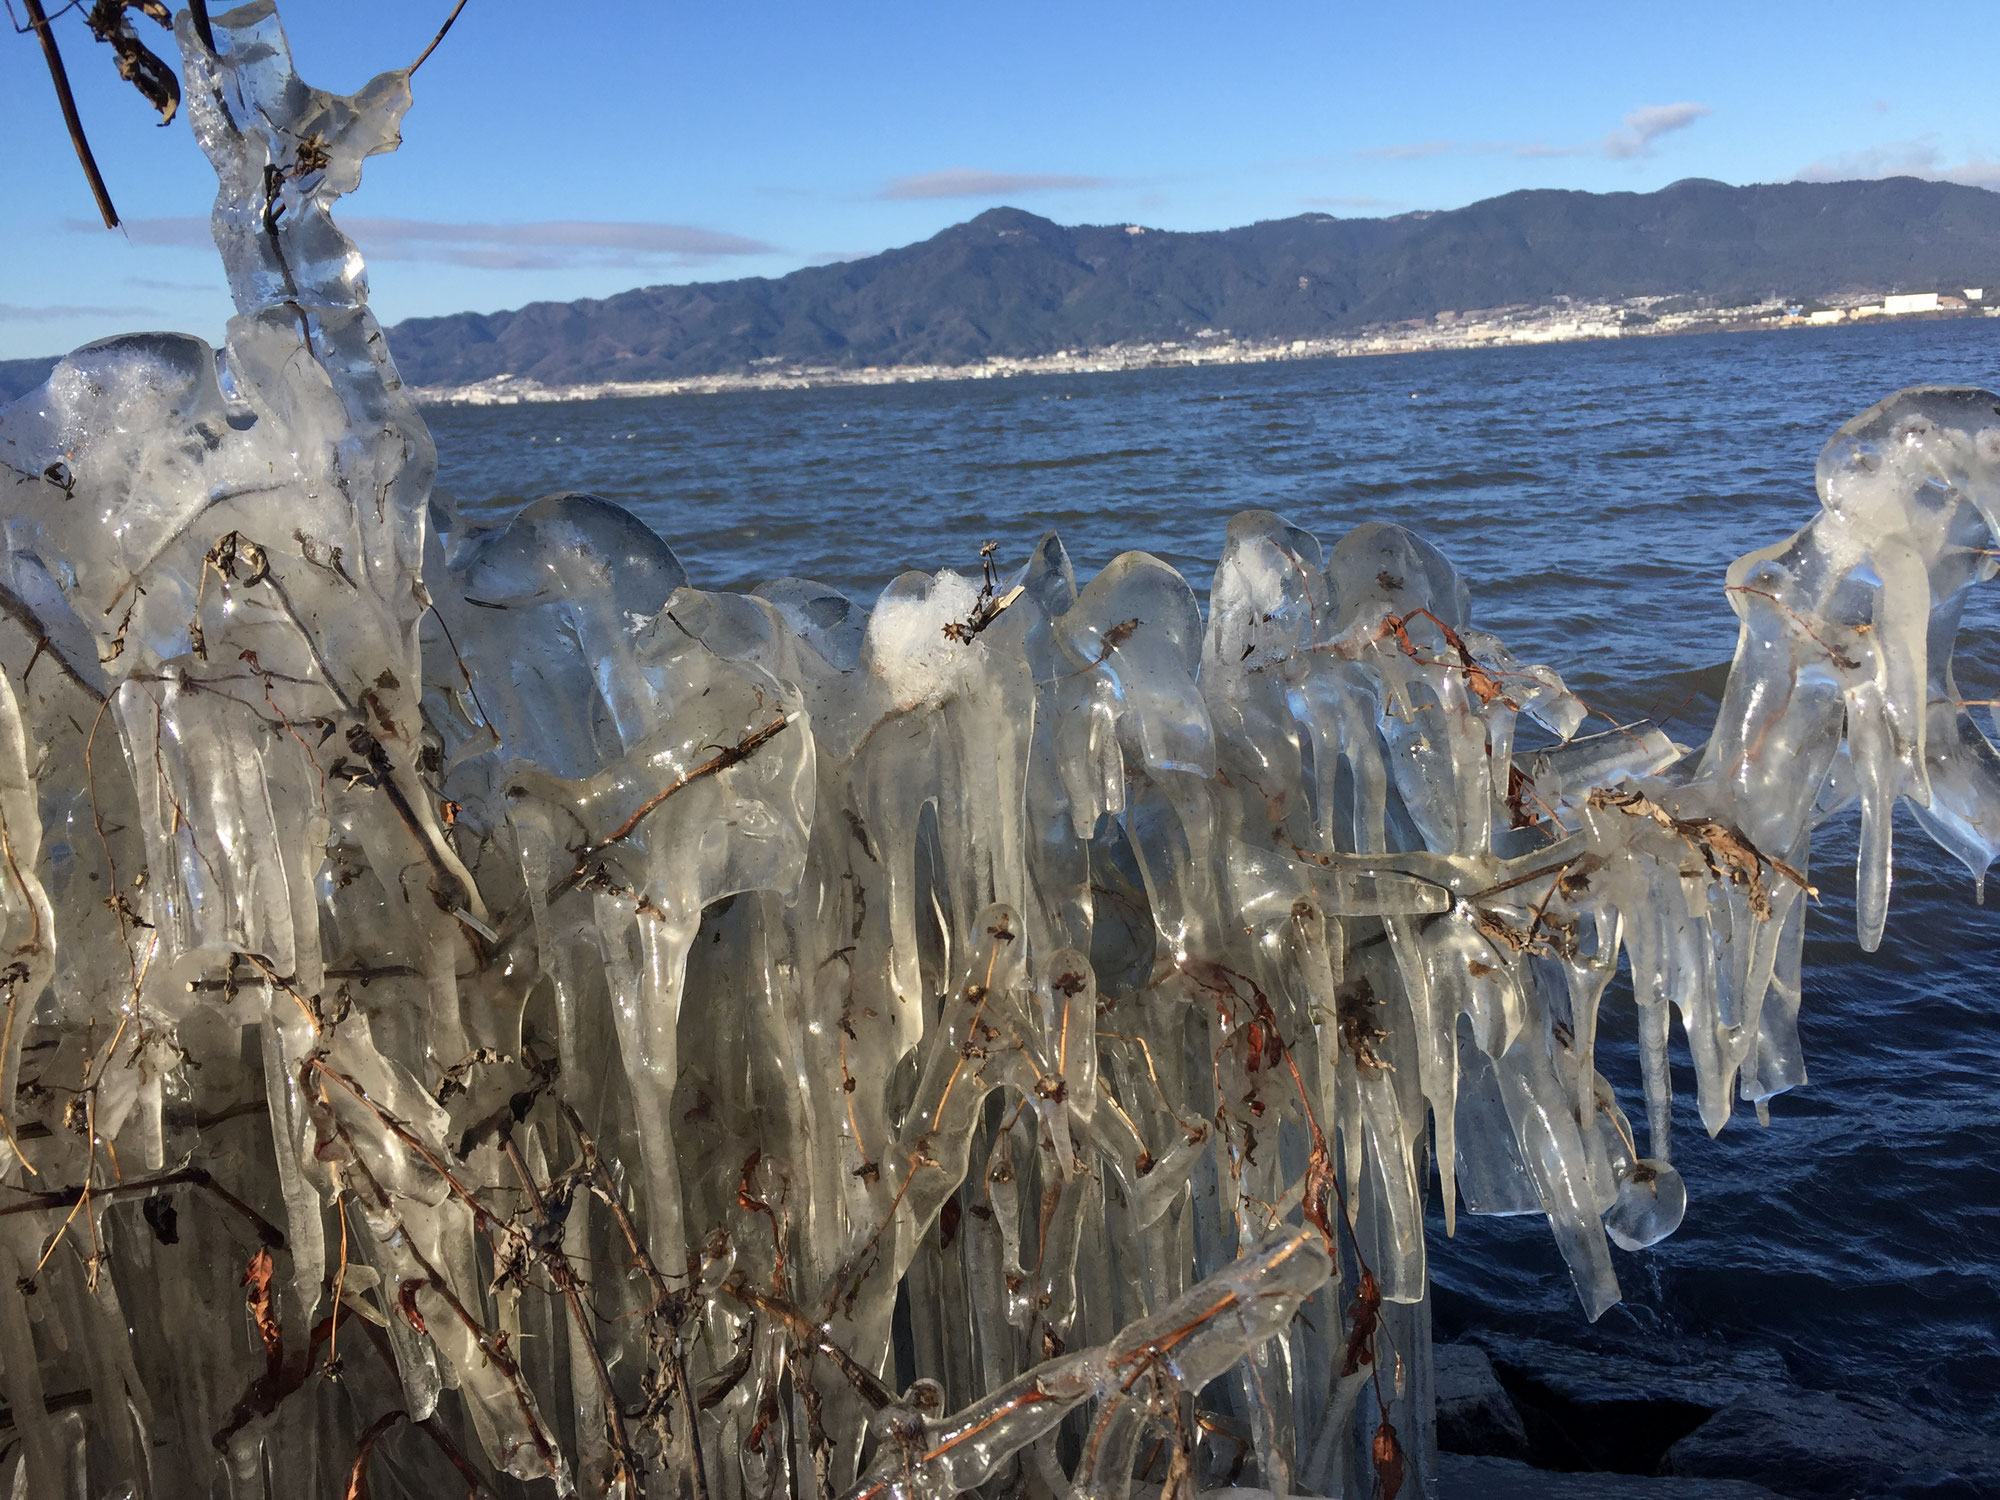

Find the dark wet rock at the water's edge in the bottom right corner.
xmin=1666 ymin=1386 xmax=2000 ymax=1500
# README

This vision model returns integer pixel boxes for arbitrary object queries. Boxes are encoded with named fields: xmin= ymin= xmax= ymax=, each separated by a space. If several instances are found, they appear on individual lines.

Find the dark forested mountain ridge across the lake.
xmin=0 ymin=178 xmax=2000 ymax=406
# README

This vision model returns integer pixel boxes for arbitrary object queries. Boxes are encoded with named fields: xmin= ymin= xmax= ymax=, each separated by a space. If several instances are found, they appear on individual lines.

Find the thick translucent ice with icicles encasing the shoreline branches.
xmin=0 ymin=2 xmax=2000 ymax=1500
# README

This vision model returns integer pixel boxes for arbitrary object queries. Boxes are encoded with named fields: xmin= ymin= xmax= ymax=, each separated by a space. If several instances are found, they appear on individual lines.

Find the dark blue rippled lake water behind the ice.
xmin=432 ymin=320 xmax=2000 ymax=1432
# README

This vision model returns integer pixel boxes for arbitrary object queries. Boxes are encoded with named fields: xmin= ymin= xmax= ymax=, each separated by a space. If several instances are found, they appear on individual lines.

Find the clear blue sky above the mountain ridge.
xmin=0 ymin=0 xmax=2000 ymax=358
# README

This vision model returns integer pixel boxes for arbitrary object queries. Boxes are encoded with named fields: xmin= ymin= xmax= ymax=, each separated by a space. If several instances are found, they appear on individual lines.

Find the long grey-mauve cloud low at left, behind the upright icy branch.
xmin=70 ymin=216 xmax=774 ymax=270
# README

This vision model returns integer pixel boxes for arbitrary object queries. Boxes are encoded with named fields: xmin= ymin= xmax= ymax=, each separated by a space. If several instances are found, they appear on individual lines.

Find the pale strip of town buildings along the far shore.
xmin=412 ymin=286 xmax=2000 ymax=406
